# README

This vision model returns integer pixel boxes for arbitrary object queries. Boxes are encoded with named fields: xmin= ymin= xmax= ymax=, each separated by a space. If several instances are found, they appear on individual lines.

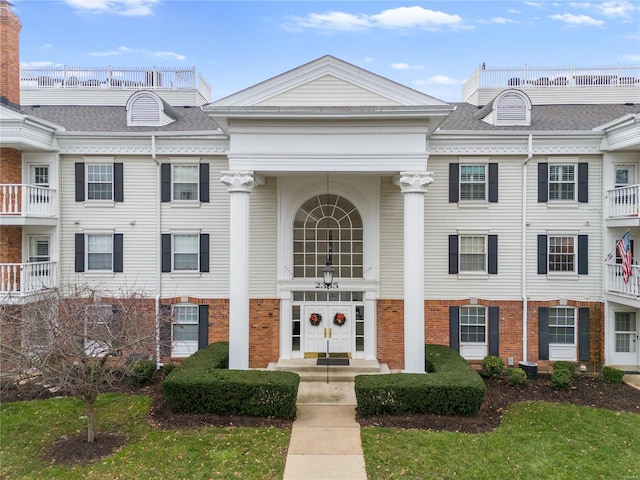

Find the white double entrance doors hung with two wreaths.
xmin=302 ymin=303 xmax=355 ymax=353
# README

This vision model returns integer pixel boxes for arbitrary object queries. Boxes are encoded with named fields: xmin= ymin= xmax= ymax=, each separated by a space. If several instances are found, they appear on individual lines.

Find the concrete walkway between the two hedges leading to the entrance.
xmin=284 ymin=381 xmax=367 ymax=480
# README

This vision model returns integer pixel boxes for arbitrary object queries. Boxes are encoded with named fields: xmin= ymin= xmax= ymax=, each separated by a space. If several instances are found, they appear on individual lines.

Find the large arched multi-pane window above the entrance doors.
xmin=293 ymin=194 xmax=363 ymax=278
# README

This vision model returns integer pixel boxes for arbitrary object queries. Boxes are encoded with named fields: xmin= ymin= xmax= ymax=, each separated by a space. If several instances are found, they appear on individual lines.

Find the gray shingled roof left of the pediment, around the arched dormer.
xmin=22 ymin=105 xmax=218 ymax=132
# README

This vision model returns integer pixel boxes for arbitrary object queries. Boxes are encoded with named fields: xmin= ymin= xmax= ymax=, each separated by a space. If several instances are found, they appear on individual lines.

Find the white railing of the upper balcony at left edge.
xmin=0 ymin=183 xmax=58 ymax=218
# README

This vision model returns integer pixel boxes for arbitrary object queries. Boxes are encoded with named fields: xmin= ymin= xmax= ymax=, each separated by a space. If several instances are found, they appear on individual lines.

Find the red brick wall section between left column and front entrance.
xmin=249 ymin=298 xmax=280 ymax=368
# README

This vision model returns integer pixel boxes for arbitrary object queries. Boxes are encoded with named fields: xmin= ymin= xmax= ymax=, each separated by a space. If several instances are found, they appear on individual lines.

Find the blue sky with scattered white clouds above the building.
xmin=11 ymin=0 xmax=640 ymax=101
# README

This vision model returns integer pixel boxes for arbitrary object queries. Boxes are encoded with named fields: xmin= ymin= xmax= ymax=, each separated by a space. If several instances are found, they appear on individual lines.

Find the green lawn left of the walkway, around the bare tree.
xmin=0 ymin=394 xmax=290 ymax=480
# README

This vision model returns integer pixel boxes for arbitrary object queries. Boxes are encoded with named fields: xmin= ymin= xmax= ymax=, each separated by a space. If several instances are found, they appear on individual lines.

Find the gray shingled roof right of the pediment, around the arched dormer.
xmin=440 ymin=103 xmax=640 ymax=131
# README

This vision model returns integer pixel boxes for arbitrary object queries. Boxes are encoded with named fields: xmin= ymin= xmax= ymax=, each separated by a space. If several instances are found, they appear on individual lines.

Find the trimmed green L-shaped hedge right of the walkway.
xmin=355 ymin=345 xmax=486 ymax=417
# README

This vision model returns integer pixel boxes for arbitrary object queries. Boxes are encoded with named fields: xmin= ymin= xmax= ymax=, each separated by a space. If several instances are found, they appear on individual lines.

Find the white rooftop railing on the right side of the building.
xmin=462 ymin=65 xmax=640 ymax=98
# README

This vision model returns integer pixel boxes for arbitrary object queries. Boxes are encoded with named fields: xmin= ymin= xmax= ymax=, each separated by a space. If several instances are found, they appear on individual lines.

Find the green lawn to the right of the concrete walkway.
xmin=362 ymin=402 xmax=640 ymax=480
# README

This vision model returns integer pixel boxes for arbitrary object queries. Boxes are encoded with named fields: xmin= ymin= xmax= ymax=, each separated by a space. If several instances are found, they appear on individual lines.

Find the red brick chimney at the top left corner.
xmin=0 ymin=0 xmax=22 ymax=107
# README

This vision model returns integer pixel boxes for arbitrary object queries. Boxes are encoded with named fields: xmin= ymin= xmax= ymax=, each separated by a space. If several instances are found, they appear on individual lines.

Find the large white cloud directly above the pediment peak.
xmin=283 ymin=7 xmax=464 ymax=31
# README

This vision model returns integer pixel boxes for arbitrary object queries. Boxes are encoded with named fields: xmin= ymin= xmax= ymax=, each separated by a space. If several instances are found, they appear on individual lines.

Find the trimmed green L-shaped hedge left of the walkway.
xmin=162 ymin=342 xmax=300 ymax=418
